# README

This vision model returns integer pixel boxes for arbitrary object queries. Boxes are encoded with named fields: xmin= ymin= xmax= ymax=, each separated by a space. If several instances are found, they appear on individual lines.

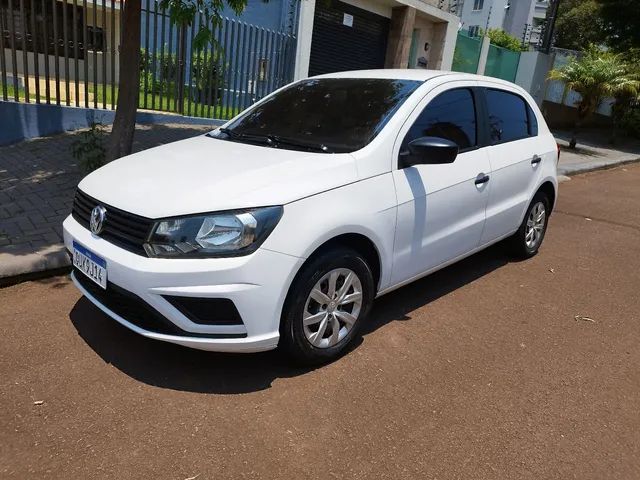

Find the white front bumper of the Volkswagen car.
xmin=63 ymin=216 xmax=304 ymax=352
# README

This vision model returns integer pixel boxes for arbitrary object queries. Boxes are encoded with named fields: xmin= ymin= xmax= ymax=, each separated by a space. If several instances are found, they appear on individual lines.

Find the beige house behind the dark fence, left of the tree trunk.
xmin=0 ymin=0 xmax=122 ymax=101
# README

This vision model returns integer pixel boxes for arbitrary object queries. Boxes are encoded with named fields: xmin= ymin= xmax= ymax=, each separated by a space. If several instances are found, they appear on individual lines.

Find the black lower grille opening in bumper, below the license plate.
xmin=73 ymin=268 xmax=247 ymax=338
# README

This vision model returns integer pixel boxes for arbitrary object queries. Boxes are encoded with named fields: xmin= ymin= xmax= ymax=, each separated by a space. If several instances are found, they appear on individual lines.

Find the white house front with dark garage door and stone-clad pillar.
xmin=295 ymin=0 xmax=459 ymax=78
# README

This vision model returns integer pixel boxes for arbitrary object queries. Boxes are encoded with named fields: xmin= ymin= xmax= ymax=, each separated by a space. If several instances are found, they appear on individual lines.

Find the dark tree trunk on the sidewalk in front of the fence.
xmin=107 ymin=0 xmax=140 ymax=161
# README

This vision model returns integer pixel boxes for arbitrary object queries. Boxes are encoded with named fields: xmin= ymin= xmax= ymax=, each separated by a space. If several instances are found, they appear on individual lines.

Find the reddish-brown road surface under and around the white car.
xmin=0 ymin=164 xmax=640 ymax=480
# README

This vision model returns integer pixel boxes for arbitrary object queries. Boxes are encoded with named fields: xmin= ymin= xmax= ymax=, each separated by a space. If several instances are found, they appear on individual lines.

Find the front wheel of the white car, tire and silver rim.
xmin=280 ymin=247 xmax=375 ymax=365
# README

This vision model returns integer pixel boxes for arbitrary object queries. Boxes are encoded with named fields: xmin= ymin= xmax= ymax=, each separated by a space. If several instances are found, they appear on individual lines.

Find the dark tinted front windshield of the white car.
xmin=215 ymin=78 xmax=421 ymax=153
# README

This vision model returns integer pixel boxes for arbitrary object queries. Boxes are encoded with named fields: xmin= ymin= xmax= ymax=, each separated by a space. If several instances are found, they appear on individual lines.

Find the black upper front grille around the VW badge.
xmin=71 ymin=189 xmax=153 ymax=256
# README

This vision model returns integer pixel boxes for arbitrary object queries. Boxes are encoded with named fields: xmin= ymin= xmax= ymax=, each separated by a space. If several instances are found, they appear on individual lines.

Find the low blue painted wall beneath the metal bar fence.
xmin=0 ymin=101 xmax=223 ymax=145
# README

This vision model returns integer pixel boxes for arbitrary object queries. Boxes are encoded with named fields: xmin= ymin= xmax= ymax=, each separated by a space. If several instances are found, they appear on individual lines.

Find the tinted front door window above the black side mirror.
xmin=401 ymin=88 xmax=476 ymax=151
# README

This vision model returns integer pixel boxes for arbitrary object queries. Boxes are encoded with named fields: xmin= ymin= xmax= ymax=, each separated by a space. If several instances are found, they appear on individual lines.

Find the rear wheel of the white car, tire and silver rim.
xmin=509 ymin=192 xmax=551 ymax=259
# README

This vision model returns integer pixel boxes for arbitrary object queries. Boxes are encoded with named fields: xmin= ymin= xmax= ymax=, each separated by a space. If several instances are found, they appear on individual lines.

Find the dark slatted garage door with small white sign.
xmin=309 ymin=0 xmax=391 ymax=76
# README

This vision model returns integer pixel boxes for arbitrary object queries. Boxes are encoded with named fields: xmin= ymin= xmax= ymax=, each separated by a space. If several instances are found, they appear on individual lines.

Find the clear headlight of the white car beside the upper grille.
xmin=144 ymin=207 xmax=283 ymax=257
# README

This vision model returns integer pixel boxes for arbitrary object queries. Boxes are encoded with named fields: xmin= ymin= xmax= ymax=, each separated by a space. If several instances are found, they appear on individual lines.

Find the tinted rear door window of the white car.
xmin=486 ymin=89 xmax=529 ymax=144
